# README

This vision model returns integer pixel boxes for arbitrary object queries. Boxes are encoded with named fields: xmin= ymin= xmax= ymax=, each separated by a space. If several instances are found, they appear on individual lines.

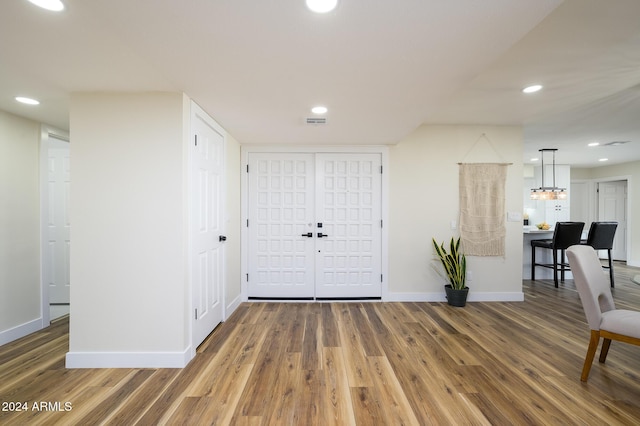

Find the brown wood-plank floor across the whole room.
xmin=0 ymin=265 xmax=640 ymax=425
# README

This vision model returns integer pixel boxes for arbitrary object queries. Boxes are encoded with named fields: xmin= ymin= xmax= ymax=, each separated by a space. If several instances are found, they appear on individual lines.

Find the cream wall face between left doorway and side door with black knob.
xmin=67 ymin=93 xmax=190 ymax=367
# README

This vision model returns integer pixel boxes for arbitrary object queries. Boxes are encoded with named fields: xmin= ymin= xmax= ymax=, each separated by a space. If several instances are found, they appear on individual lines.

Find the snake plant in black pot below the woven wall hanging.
xmin=431 ymin=237 xmax=469 ymax=306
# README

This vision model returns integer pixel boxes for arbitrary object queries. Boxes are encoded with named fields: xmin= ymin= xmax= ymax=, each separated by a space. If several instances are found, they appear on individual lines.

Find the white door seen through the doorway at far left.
xmin=46 ymin=137 xmax=71 ymax=305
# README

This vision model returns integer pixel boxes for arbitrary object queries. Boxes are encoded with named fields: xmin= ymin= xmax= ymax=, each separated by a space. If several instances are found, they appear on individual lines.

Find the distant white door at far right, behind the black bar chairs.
xmin=598 ymin=180 xmax=627 ymax=261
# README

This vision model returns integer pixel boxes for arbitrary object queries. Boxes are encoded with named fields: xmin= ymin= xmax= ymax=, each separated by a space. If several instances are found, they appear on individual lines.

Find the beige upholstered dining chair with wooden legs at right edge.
xmin=567 ymin=245 xmax=640 ymax=382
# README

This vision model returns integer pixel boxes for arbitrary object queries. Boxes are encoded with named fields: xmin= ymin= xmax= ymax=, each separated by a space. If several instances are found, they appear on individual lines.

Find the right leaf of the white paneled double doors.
xmin=316 ymin=154 xmax=382 ymax=298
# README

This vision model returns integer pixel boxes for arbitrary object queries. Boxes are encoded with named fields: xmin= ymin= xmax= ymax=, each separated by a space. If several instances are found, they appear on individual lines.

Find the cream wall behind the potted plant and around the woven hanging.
xmin=389 ymin=125 xmax=523 ymax=301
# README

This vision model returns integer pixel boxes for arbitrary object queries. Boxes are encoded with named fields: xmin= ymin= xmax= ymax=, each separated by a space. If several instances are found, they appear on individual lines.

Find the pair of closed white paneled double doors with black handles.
xmin=247 ymin=153 xmax=383 ymax=299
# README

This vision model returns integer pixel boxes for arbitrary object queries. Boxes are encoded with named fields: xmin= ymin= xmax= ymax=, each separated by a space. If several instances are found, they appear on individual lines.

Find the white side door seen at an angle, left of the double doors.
xmin=191 ymin=108 xmax=226 ymax=348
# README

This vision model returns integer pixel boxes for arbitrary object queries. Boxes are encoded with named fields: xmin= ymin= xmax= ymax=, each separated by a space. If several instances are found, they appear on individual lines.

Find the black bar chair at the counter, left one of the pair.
xmin=531 ymin=222 xmax=584 ymax=287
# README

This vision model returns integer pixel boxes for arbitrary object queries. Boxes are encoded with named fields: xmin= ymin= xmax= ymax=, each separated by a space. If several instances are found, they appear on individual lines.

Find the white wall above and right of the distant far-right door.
xmin=571 ymin=161 xmax=640 ymax=266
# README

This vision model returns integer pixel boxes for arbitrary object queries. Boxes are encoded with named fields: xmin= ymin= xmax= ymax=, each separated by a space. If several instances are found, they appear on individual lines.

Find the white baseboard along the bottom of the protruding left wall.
xmin=66 ymin=347 xmax=192 ymax=368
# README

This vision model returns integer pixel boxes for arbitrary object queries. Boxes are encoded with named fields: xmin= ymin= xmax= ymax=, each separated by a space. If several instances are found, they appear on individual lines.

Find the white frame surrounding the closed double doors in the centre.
xmin=240 ymin=145 xmax=389 ymax=301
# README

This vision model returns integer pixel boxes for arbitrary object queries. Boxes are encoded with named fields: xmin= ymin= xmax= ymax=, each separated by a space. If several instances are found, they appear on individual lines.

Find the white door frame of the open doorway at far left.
xmin=40 ymin=125 xmax=69 ymax=328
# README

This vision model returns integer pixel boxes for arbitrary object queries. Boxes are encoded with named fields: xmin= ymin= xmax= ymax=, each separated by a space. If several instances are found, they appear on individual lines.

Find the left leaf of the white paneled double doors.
xmin=248 ymin=154 xmax=314 ymax=298
